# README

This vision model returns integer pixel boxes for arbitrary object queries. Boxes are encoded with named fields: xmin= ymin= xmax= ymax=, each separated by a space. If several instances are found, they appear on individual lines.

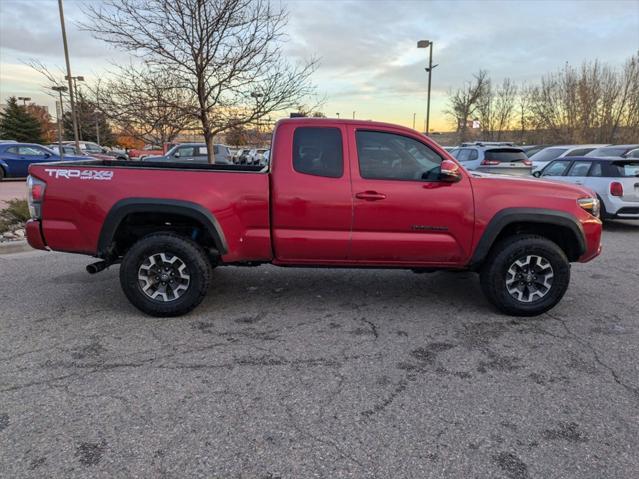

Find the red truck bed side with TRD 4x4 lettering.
xmin=29 ymin=160 xmax=272 ymax=262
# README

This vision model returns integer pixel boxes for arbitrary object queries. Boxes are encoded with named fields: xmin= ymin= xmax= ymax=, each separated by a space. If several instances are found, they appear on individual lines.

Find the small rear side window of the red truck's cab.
xmin=293 ymin=127 xmax=344 ymax=178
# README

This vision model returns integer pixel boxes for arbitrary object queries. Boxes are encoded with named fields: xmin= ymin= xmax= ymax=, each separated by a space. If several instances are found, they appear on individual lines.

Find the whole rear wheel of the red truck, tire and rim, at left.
xmin=120 ymin=232 xmax=212 ymax=317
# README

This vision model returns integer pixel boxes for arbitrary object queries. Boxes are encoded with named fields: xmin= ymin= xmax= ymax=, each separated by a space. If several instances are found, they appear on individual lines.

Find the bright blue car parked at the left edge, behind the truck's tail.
xmin=0 ymin=143 xmax=89 ymax=181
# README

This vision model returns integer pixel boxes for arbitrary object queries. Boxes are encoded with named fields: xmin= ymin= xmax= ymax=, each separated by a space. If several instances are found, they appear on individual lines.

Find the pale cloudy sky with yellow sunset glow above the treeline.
xmin=0 ymin=0 xmax=639 ymax=131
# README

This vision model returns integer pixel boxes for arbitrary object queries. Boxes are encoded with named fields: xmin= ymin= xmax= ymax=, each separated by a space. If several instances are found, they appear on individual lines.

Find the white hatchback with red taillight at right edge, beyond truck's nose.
xmin=535 ymin=156 xmax=639 ymax=219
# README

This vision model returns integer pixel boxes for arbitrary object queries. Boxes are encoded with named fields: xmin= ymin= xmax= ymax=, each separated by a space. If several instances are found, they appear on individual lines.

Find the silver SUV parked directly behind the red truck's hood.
xmin=450 ymin=145 xmax=531 ymax=176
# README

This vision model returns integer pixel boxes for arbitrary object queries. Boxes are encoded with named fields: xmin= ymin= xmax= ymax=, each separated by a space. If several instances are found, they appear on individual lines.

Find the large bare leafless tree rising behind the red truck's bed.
xmin=84 ymin=0 xmax=315 ymax=162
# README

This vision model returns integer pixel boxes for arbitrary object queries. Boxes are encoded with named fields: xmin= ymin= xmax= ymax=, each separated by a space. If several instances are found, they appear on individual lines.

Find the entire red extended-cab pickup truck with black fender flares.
xmin=27 ymin=118 xmax=601 ymax=316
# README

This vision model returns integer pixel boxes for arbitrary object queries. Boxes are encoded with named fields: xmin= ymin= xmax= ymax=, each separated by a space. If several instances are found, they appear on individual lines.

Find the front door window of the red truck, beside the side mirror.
xmin=356 ymin=131 xmax=442 ymax=181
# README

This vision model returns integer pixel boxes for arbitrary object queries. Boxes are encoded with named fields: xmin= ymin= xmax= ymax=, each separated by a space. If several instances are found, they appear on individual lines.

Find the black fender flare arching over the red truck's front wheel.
xmin=470 ymin=208 xmax=586 ymax=267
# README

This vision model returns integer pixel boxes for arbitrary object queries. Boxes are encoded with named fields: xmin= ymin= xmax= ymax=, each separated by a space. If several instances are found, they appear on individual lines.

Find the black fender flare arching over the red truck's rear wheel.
xmin=97 ymin=198 xmax=228 ymax=257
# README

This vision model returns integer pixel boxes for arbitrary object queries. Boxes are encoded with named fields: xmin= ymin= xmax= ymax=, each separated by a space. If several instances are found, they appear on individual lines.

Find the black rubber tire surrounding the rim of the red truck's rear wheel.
xmin=120 ymin=232 xmax=212 ymax=317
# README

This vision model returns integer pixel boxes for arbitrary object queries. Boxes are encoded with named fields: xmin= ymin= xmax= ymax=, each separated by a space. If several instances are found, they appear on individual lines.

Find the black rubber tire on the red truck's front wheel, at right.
xmin=480 ymin=235 xmax=570 ymax=316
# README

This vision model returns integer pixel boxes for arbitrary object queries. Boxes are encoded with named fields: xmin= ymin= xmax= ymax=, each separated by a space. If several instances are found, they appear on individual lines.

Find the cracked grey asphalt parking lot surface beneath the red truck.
xmin=0 ymin=222 xmax=639 ymax=479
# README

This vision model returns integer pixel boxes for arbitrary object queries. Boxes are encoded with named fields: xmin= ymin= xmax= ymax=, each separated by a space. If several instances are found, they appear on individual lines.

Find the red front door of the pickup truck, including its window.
xmin=349 ymin=127 xmax=474 ymax=266
